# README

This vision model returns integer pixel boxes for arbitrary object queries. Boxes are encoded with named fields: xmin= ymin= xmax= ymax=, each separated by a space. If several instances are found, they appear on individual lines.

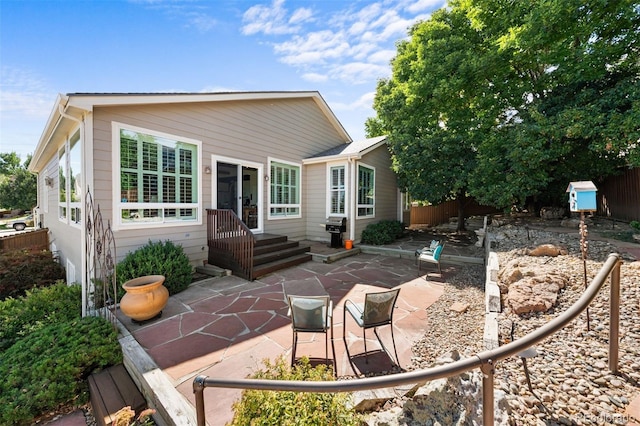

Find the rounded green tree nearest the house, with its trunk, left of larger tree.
xmin=367 ymin=9 xmax=504 ymax=230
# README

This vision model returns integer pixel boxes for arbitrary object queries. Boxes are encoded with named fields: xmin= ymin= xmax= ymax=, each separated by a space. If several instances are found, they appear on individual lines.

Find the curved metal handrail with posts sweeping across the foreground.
xmin=193 ymin=253 xmax=622 ymax=426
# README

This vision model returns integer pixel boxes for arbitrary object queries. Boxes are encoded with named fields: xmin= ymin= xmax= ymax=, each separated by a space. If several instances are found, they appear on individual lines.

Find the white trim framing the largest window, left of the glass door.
xmin=111 ymin=121 xmax=203 ymax=230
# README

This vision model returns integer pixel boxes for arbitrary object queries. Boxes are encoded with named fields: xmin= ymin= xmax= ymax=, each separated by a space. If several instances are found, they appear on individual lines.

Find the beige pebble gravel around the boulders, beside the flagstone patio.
xmin=404 ymin=225 xmax=640 ymax=426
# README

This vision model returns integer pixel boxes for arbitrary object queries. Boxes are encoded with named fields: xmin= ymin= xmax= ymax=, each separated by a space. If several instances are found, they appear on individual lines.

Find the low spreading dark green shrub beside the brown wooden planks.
xmin=0 ymin=317 xmax=122 ymax=425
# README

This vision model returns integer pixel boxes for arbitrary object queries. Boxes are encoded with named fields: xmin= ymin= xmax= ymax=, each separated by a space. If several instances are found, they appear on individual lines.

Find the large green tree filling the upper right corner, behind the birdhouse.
xmin=464 ymin=0 xmax=640 ymax=211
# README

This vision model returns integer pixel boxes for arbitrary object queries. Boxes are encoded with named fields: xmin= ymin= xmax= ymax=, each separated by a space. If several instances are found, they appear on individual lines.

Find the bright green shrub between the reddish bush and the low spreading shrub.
xmin=0 ymin=281 xmax=82 ymax=352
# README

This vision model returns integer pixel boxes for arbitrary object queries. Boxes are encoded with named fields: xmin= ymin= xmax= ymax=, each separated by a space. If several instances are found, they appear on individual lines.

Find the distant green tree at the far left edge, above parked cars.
xmin=0 ymin=152 xmax=37 ymax=210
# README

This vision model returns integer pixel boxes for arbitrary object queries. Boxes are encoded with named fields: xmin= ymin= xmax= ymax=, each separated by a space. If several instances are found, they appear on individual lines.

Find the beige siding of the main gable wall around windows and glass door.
xmin=93 ymin=98 xmax=344 ymax=264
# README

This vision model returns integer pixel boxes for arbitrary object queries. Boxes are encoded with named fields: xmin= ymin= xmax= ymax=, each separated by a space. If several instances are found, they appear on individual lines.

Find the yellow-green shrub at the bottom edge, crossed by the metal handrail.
xmin=230 ymin=356 xmax=360 ymax=426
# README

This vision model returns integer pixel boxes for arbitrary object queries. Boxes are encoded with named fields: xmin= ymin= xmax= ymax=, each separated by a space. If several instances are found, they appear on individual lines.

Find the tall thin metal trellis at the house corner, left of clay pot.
xmin=82 ymin=188 xmax=118 ymax=325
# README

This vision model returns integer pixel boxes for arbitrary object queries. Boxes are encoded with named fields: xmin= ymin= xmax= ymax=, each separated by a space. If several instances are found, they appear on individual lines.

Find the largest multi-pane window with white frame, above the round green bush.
xmin=114 ymin=124 xmax=200 ymax=225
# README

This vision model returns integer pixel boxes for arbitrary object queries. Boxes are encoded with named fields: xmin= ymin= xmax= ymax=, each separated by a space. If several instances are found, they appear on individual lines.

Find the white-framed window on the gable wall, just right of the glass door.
xmin=269 ymin=161 xmax=301 ymax=218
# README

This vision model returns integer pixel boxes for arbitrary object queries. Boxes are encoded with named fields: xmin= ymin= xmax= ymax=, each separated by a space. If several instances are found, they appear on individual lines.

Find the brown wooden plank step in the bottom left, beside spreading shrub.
xmin=88 ymin=364 xmax=147 ymax=426
